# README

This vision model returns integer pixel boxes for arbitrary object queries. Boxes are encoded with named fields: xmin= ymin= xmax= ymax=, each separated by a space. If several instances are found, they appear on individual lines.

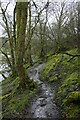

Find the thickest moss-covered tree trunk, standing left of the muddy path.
xmin=16 ymin=1 xmax=28 ymax=88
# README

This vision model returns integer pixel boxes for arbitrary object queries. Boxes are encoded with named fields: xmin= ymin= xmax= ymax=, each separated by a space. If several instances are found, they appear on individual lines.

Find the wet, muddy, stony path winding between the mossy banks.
xmin=25 ymin=64 xmax=60 ymax=118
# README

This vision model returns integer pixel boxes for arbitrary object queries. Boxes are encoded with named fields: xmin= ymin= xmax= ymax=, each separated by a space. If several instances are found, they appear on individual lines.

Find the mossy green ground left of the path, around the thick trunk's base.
xmin=0 ymin=72 xmax=39 ymax=118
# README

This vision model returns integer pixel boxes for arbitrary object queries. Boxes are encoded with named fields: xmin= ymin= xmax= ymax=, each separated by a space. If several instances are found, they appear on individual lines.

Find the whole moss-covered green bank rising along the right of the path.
xmin=40 ymin=49 xmax=80 ymax=118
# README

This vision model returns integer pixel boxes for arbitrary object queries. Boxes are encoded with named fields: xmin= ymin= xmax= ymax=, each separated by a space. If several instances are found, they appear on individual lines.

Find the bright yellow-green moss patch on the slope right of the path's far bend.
xmin=41 ymin=54 xmax=62 ymax=80
